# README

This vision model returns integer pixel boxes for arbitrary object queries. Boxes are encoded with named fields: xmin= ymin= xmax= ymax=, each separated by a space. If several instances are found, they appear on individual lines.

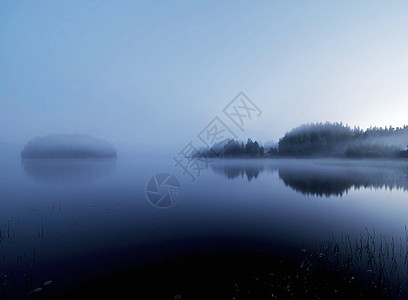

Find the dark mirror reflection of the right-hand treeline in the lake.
xmin=211 ymin=159 xmax=408 ymax=197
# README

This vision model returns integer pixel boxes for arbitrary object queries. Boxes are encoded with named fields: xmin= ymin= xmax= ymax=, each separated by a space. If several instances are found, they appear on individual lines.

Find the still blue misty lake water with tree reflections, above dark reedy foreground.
xmin=0 ymin=157 xmax=408 ymax=294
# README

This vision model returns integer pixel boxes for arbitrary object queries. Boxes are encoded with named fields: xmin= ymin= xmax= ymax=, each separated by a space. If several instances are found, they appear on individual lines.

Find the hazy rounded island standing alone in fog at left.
xmin=21 ymin=134 xmax=116 ymax=159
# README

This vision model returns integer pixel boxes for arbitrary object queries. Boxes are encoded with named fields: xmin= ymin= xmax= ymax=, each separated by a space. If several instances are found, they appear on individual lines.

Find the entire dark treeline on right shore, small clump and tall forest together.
xmin=204 ymin=122 xmax=408 ymax=158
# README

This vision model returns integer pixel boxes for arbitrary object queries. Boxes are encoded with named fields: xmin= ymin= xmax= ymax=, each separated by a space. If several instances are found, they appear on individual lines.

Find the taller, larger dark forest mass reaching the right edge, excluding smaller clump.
xmin=278 ymin=122 xmax=408 ymax=157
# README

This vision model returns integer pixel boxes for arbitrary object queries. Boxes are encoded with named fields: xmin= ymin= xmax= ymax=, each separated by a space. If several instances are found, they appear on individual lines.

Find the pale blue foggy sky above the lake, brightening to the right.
xmin=0 ymin=0 xmax=408 ymax=148
